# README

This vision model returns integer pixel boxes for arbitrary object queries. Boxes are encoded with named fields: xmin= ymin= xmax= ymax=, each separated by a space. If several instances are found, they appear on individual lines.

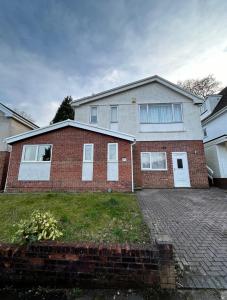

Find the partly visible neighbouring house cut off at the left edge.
xmin=0 ymin=103 xmax=38 ymax=191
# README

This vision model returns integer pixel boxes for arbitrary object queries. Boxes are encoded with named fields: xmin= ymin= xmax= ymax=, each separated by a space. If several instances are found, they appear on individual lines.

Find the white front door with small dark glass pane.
xmin=172 ymin=152 xmax=191 ymax=187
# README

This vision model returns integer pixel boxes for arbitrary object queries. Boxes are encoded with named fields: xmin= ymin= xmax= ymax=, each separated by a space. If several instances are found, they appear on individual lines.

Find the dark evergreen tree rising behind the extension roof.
xmin=51 ymin=96 xmax=74 ymax=123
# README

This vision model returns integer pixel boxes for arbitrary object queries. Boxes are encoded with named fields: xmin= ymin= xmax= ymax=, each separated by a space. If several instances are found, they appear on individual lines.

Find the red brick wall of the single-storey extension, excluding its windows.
xmin=7 ymin=127 xmax=131 ymax=192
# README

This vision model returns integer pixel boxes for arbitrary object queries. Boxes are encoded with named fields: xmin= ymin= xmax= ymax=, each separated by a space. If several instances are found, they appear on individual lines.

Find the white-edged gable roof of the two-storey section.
xmin=72 ymin=75 xmax=204 ymax=106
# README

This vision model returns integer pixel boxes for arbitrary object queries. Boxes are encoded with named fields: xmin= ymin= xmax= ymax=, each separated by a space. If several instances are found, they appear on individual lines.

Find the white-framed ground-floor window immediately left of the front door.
xmin=141 ymin=152 xmax=167 ymax=171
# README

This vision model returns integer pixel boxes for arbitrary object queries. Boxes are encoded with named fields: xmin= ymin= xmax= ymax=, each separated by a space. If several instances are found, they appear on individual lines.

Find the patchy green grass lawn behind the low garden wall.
xmin=0 ymin=193 xmax=149 ymax=244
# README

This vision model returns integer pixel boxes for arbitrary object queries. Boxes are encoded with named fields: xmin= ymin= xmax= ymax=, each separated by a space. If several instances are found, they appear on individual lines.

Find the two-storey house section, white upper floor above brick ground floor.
xmin=72 ymin=75 xmax=208 ymax=188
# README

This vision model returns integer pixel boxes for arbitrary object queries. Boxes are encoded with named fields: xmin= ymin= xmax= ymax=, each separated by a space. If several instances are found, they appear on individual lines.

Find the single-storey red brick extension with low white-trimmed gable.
xmin=5 ymin=120 xmax=135 ymax=192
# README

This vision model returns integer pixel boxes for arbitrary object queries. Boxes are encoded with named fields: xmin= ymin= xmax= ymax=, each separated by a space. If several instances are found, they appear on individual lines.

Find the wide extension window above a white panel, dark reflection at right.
xmin=22 ymin=145 xmax=52 ymax=162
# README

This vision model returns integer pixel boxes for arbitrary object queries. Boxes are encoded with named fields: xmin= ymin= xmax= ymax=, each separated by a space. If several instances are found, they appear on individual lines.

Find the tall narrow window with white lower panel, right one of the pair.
xmin=107 ymin=143 xmax=119 ymax=181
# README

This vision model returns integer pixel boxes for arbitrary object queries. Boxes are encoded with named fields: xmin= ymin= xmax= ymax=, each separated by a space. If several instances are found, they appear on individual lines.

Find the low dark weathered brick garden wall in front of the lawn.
xmin=0 ymin=242 xmax=175 ymax=288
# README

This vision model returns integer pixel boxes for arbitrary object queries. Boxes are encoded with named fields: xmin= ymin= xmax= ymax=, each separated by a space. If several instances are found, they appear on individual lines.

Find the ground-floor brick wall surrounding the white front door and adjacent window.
xmin=133 ymin=141 xmax=208 ymax=188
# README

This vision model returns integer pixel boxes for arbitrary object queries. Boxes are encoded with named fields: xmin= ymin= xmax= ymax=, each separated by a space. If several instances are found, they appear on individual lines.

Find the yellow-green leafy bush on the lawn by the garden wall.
xmin=13 ymin=210 xmax=63 ymax=244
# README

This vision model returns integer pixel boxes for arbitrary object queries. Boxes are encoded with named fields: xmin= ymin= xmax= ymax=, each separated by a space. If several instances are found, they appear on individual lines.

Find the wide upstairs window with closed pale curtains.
xmin=139 ymin=103 xmax=182 ymax=124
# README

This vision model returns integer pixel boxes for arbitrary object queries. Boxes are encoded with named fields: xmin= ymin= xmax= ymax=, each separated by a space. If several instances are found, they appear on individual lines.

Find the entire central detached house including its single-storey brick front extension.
xmin=5 ymin=76 xmax=208 ymax=192
